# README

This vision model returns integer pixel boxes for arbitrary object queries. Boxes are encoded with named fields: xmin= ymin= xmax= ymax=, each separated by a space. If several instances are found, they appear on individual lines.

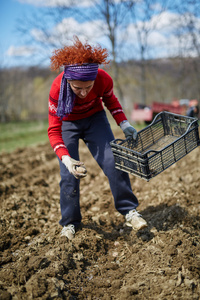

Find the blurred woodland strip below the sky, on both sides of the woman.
xmin=0 ymin=57 xmax=200 ymax=122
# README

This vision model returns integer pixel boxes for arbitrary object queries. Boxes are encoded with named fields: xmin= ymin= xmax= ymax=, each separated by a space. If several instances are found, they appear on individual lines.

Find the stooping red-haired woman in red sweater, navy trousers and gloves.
xmin=48 ymin=37 xmax=147 ymax=239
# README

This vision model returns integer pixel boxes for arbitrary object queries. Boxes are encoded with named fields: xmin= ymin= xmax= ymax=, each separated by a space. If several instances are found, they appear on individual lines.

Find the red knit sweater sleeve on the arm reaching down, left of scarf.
xmin=48 ymin=73 xmax=69 ymax=159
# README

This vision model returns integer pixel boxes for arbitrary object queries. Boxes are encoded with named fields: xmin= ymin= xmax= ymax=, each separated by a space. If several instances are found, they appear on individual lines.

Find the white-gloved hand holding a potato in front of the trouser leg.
xmin=62 ymin=155 xmax=87 ymax=179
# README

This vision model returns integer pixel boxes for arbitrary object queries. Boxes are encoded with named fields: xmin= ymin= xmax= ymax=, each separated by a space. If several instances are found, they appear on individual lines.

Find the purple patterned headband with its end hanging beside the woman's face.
xmin=57 ymin=64 xmax=99 ymax=119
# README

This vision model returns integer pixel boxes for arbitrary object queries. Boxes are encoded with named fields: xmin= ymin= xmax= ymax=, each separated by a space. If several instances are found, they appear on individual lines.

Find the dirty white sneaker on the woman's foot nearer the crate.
xmin=125 ymin=209 xmax=148 ymax=230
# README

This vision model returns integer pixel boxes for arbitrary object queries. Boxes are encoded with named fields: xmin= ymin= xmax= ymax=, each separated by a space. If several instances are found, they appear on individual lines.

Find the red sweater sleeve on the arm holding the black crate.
xmin=101 ymin=70 xmax=127 ymax=125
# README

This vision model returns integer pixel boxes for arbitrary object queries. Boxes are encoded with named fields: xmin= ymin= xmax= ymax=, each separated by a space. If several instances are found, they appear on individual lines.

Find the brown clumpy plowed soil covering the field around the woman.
xmin=0 ymin=129 xmax=200 ymax=300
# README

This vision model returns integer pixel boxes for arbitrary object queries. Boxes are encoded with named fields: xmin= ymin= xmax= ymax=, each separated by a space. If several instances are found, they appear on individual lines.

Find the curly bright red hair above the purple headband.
xmin=51 ymin=36 xmax=109 ymax=70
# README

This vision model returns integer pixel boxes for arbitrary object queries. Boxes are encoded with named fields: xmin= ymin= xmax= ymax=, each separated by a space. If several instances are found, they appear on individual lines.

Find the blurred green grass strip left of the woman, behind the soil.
xmin=0 ymin=121 xmax=48 ymax=152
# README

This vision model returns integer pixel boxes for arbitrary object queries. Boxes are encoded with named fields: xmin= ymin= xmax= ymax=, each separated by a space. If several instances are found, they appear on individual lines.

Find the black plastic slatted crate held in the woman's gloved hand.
xmin=110 ymin=111 xmax=200 ymax=181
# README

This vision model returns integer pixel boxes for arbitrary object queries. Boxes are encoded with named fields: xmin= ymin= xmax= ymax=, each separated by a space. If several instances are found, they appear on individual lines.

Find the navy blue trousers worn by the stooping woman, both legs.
xmin=59 ymin=111 xmax=138 ymax=226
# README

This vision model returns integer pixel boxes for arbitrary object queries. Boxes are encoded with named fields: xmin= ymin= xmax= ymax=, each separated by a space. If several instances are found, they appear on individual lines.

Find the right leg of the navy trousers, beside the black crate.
xmin=82 ymin=112 xmax=138 ymax=215
